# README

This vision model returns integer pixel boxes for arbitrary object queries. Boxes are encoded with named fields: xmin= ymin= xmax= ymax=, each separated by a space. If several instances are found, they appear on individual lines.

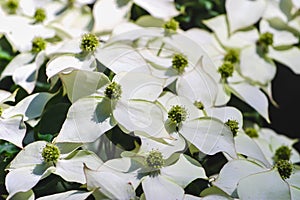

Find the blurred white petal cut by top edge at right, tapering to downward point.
xmin=225 ymin=0 xmax=267 ymax=33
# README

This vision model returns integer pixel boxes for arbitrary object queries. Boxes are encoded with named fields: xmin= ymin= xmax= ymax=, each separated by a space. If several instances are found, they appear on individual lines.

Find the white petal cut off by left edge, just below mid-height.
xmin=0 ymin=116 xmax=26 ymax=148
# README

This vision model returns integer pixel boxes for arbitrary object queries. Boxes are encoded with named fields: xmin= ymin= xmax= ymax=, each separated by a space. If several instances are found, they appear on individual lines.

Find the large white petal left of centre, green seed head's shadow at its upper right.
xmin=56 ymin=98 xmax=116 ymax=143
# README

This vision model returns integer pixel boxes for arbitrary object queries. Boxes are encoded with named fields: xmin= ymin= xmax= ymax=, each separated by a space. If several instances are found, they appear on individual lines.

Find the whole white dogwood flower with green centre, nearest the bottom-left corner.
xmin=5 ymin=141 xmax=102 ymax=199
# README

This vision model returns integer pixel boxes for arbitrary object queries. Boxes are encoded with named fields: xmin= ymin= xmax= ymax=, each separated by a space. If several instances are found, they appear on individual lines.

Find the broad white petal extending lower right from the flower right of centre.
xmin=180 ymin=118 xmax=237 ymax=158
